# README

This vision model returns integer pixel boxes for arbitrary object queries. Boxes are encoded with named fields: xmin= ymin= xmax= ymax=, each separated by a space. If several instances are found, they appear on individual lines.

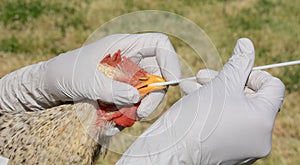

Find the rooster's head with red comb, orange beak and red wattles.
xmin=98 ymin=50 xmax=166 ymax=128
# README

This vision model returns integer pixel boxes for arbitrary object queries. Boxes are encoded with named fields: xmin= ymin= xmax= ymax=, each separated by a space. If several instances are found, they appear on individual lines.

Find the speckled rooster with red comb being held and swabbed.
xmin=0 ymin=50 xmax=165 ymax=164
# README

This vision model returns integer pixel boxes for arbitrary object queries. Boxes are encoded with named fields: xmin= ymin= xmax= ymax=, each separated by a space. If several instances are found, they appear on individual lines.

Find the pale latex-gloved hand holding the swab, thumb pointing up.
xmin=117 ymin=39 xmax=285 ymax=165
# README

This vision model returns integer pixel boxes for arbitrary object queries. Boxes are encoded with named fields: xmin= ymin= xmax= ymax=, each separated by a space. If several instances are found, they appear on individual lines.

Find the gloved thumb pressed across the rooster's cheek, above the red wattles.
xmin=90 ymin=72 xmax=140 ymax=105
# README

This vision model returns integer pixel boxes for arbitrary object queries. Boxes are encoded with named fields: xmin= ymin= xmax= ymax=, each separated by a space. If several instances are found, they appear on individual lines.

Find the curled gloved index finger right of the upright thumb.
xmin=247 ymin=71 xmax=285 ymax=112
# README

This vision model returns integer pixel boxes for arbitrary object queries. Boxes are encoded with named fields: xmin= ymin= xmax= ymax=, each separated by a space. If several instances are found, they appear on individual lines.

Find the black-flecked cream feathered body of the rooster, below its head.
xmin=0 ymin=102 xmax=113 ymax=164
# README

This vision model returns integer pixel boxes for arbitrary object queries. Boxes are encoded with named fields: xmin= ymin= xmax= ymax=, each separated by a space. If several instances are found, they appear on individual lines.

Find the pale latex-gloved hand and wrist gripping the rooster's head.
xmin=0 ymin=33 xmax=180 ymax=117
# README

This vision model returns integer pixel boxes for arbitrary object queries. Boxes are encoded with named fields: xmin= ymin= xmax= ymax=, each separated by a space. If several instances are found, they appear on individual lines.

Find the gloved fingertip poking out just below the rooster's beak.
xmin=137 ymin=90 xmax=165 ymax=118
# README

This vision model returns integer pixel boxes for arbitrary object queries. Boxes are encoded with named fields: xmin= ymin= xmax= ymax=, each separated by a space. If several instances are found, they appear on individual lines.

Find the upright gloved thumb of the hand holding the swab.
xmin=218 ymin=38 xmax=255 ymax=92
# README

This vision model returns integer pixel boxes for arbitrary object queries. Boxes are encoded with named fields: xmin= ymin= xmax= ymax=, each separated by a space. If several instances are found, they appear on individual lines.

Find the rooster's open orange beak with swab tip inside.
xmin=135 ymin=74 xmax=166 ymax=97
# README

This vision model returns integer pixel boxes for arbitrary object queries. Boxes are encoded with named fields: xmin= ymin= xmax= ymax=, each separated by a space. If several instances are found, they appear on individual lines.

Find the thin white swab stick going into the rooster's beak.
xmin=148 ymin=60 xmax=300 ymax=86
